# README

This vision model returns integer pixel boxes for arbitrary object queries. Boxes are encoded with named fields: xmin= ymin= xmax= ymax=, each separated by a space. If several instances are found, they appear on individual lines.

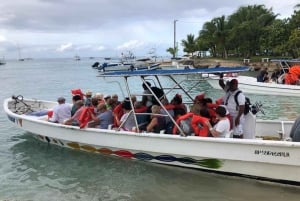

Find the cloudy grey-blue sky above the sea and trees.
xmin=0 ymin=0 xmax=299 ymax=59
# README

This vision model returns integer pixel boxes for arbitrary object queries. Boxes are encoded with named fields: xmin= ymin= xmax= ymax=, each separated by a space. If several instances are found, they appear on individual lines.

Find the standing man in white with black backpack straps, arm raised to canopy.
xmin=219 ymin=75 xmax=246 ymax=138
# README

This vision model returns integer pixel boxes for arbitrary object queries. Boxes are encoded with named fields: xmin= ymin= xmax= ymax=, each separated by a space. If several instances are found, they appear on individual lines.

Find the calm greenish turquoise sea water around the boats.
xmin=0 ymin=59 xmax=300 ymax=201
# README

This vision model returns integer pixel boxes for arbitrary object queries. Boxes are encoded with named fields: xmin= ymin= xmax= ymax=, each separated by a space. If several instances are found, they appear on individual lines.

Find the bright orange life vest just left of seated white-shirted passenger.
xmin=191 ymin=115 xmax=209 ymax=137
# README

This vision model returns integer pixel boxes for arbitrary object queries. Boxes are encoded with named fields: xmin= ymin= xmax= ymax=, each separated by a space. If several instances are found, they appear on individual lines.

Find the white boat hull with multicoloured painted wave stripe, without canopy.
xmin=4 ymin=99 xmax=300 ymax=183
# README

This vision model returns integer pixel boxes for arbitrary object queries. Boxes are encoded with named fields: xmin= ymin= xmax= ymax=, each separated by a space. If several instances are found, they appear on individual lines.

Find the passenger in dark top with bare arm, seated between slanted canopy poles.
xmin=147 ymin=105 xmax=166 ymax=133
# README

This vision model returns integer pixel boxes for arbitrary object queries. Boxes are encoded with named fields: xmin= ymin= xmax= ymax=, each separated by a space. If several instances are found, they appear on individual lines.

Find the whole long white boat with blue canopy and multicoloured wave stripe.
xmin=4 ymin=67 xmax=300 ymax=185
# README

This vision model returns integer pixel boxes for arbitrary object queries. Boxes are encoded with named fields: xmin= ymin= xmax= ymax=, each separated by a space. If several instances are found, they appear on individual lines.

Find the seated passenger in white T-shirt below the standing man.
xmin=207 ymin=106 xmax=230 ymax=138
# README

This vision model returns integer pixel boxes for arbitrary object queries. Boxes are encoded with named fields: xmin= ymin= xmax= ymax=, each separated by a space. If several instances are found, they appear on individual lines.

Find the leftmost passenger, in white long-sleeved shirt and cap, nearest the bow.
xmin=48 ymin=97 xmax=71 ymax=124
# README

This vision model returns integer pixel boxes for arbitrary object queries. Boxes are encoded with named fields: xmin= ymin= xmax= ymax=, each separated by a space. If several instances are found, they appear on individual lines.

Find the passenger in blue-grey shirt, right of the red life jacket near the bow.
xmin=90 ymin=103 xmax=113 ymax=129
